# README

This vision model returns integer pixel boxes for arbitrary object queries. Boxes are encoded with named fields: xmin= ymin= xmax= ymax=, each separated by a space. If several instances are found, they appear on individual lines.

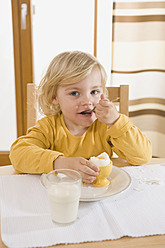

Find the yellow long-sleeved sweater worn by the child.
xmin=10 ymin=113 xmax=152 ymax=173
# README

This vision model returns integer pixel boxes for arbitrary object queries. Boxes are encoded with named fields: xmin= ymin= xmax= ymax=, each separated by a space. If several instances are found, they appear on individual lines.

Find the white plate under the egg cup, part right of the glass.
xmin=80 ymin=166 xmax=131 ymax=201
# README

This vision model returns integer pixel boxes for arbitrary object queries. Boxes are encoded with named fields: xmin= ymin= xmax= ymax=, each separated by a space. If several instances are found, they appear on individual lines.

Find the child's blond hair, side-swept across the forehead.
xmin=38 ymin=51 xmax=107 ymax=115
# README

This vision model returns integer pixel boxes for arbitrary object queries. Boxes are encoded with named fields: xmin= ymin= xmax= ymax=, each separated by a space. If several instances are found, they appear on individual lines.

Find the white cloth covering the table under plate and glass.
xmin=0 ymin=164 xmax=165 ymax=248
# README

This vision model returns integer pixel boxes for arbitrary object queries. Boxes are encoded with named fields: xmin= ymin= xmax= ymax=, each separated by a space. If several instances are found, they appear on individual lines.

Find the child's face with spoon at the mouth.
xmin=52 ymin=66 xmax=103 ymax=131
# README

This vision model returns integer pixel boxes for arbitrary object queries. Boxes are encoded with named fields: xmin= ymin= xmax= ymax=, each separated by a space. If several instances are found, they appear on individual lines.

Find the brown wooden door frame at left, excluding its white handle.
xmin=0 ymin=0 xmax=34 ymax=165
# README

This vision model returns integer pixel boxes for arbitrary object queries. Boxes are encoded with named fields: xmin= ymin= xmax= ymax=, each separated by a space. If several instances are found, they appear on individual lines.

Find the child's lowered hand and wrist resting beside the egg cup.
xmin=54 ymin=156 xmax=99 ymax=183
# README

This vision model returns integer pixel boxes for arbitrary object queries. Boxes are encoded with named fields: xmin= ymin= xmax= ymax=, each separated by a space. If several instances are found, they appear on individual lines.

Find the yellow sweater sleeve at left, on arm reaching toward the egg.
xmin=10 ymin=118 xmax=63 ymax=174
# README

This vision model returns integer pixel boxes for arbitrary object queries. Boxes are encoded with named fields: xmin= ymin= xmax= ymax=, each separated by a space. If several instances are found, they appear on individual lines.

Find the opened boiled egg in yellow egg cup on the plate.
xmin=89 ymin=152 xmax=112 ymax=187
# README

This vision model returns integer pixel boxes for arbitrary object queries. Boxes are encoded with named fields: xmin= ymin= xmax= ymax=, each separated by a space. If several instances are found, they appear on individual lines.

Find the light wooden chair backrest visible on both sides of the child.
xmin=27 ymin=83 xmax=129 ymax=129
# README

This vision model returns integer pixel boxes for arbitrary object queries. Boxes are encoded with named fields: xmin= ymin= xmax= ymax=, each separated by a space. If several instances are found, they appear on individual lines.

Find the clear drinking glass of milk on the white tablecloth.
xmin=47 ymin=183 xmax=80 ymax=223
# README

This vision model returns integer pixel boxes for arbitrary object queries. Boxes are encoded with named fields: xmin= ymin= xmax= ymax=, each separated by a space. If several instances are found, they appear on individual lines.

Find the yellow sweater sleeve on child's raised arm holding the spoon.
xmin=107 ymin=115 xmax=152 ymax=165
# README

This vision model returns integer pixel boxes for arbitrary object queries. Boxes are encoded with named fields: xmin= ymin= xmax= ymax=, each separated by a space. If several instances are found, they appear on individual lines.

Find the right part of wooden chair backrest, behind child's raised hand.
xmin=106 ymin=85 xmax=129 ymax=116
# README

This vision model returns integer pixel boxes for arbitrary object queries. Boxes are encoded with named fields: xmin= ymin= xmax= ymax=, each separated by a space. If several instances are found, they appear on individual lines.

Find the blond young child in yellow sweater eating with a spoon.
xmin=10 ymin=51 xmax=152 ymax=183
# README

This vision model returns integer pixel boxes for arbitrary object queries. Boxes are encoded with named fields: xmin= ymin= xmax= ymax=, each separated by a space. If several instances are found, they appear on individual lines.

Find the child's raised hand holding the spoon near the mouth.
xmin=95 ymin=94 xmax=120 ymax=127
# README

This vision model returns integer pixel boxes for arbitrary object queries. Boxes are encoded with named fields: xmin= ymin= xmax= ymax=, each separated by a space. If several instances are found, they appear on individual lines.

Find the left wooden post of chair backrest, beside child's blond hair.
xmin=27 ymin=83 xmax=37 ymax=129
